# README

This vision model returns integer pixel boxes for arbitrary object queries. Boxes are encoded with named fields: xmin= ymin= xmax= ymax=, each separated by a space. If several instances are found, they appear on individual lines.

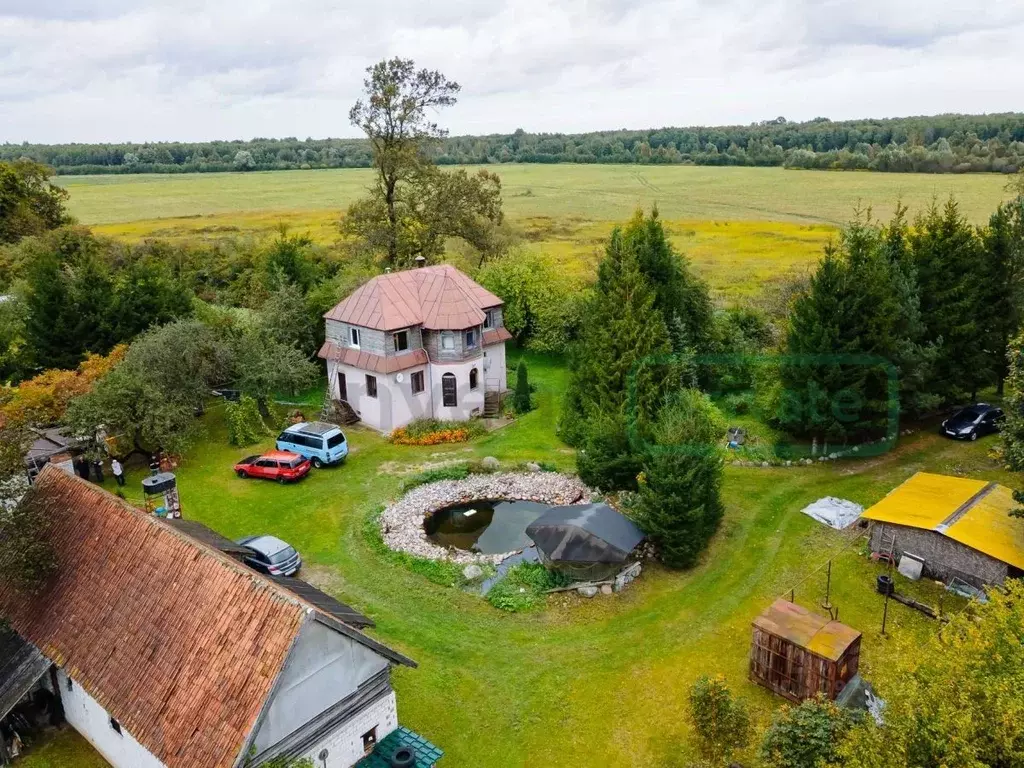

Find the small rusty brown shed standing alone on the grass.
xmin=750 ymin=599 xmax=860 ymax=703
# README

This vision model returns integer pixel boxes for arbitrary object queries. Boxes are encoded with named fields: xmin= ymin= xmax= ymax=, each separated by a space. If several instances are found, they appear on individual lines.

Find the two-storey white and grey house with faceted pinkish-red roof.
xmin=319 ymin=264 xmax=512 ymax=432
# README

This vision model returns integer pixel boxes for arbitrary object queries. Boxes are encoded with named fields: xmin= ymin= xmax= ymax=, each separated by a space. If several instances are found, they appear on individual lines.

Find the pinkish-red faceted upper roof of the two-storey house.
xmin=324 ymin=264 xmax=502 ymax=331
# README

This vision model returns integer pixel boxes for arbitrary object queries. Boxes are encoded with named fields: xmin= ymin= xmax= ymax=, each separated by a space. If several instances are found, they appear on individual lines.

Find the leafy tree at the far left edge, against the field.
xmin=0 ymin=160 xmax=71 ymax=243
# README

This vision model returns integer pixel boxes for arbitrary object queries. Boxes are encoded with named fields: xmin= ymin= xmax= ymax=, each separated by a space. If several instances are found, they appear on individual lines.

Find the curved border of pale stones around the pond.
xmin=381 ymin=472 xmax=596 ymax=565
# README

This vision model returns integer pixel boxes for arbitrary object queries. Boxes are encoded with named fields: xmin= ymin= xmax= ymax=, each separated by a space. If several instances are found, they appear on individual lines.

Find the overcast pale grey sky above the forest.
xmin=0 ymin=0 xmax=1024 ymax=142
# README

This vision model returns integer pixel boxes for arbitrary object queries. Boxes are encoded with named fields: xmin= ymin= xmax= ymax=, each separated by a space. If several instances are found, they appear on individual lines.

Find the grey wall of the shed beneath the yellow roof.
xmin=871 ymin=522 xmax=1009 ymax=587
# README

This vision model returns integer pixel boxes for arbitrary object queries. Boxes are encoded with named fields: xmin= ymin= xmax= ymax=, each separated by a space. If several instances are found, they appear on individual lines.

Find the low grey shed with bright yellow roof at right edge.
xmin=863 ymin=472 xmax=1024 ymax=587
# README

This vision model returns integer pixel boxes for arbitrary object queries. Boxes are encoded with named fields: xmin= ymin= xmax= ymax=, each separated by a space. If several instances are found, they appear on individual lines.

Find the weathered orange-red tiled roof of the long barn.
xmin=0 ymin=465 xmax=409 ymax=768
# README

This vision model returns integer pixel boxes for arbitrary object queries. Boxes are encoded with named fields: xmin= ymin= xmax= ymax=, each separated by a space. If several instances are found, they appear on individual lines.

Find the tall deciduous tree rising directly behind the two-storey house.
xmin=342 ymin=58 xmax=502 ymax=267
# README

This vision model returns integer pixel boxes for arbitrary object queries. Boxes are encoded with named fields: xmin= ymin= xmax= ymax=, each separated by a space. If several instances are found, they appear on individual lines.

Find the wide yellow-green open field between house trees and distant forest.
xmin=59 ymin=165 xmax=1006 ymax=302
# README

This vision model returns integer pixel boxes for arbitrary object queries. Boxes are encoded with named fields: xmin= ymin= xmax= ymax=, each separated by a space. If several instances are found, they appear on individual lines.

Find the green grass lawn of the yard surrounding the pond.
xmin=72 ymin=356 xmax=1006 ymax=768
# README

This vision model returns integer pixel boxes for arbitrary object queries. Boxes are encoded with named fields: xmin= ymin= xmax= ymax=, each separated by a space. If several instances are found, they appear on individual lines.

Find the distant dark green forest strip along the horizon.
xmin=6 ymin=113 xmax=1024 ymax=174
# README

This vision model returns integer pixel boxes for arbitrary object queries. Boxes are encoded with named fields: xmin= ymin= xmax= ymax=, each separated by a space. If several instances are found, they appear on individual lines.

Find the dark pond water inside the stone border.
xmin=423 ymin=499 xmax=551 ymax=555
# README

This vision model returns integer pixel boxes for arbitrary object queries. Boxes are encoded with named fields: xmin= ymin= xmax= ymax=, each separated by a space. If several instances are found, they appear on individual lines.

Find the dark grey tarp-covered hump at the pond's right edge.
xmin=526 ymin=504 xmax=644 ymax=563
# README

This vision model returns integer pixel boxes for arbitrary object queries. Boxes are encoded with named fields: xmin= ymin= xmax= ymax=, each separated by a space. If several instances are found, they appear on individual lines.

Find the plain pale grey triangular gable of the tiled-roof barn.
xmin=254 ymin=621 xmax=388 ymax=754
